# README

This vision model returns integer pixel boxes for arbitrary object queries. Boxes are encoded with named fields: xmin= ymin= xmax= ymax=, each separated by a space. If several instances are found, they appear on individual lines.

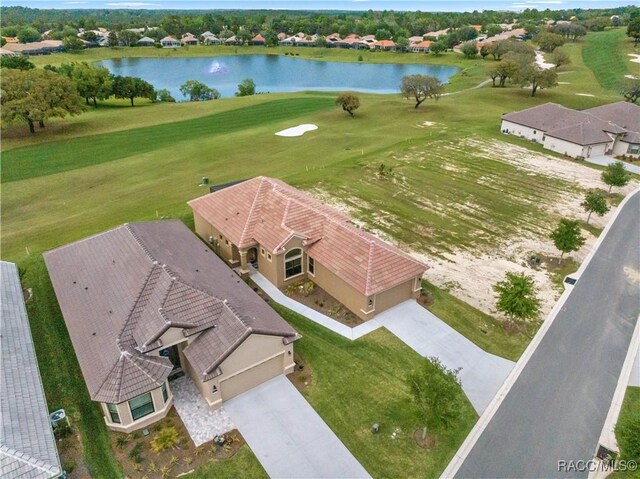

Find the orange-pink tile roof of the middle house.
xmin=189 ymin=177 xmax=427 ymax=296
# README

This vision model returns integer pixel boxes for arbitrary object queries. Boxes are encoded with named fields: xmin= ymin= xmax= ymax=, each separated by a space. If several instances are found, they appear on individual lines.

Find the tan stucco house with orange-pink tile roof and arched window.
xmin=189 ymin=177 xmax=427 ymax=320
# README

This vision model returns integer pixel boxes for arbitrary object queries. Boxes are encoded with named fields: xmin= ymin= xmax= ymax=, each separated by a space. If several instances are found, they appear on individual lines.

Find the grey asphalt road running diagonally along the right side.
xmin=456 ymin=193 xmax=640 ymax=478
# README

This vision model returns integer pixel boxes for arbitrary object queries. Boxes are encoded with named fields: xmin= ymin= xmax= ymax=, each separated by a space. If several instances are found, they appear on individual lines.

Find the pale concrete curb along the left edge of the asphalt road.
xmin=440 ymin=188 xmax=640 ymax=479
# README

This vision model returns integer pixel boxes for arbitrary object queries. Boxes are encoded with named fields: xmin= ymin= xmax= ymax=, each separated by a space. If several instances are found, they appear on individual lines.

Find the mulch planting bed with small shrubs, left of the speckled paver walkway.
xmin=110 ymin=408 xmax=245 ymax=479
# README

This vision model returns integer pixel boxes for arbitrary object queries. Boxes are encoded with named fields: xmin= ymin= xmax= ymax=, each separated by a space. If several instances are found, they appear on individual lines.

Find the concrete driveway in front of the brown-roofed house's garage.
xmin=224 ymin=376 xmax=371 ymax=479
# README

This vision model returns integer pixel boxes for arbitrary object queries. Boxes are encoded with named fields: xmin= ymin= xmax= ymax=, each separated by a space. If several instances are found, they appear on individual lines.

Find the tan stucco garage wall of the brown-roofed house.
xmin=186 ymin=334 xmax=295 ymax=407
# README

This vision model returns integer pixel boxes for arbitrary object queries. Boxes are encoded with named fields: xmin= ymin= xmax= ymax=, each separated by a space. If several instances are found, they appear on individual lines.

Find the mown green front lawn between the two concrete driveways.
xmin=274 ymin=305 xmax=477 ymax=478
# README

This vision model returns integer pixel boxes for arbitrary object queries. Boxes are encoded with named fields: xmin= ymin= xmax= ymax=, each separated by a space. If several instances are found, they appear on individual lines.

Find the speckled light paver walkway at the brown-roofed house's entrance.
xmin=169 ymin=375 xmax=235 ymax=447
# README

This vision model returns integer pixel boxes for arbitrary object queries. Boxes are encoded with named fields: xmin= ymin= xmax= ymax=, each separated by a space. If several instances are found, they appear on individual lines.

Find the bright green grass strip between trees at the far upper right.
xmin=582 ymin=28 xmax=640 ymax=91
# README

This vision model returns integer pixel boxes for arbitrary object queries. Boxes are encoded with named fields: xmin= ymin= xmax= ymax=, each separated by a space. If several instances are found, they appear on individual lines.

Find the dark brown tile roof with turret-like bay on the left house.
xmin=44 ymin=221 xmax=299 ymax=403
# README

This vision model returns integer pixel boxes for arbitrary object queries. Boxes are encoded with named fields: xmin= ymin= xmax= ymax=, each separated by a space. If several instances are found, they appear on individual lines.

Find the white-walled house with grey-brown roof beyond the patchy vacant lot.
xmin=501 ymin=102 xmax=640 ymax=158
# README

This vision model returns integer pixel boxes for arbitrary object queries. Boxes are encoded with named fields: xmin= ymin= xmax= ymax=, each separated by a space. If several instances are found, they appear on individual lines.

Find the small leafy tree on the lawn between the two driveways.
xmin=406 ymin=357 xmax=461 ymax=440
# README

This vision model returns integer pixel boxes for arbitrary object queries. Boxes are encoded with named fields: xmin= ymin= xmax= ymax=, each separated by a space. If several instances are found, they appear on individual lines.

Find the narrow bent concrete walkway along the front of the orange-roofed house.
xmin=251 ymin=271 xmax=382 ymax=339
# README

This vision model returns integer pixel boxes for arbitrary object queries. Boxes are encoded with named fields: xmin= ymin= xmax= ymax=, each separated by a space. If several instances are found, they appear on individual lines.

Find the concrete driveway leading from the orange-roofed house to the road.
xmin=376 ymin=301 xmax=515 ymax=414
